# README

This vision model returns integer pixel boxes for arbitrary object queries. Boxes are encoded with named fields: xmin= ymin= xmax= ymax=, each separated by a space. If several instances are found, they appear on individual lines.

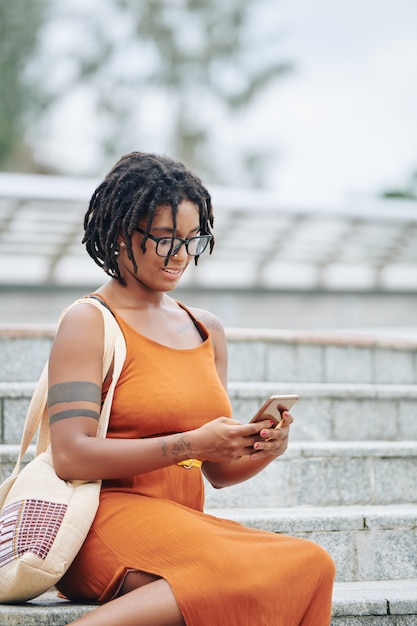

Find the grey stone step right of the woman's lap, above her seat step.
xmin=206 ymin=504 xmax=417 ymax=582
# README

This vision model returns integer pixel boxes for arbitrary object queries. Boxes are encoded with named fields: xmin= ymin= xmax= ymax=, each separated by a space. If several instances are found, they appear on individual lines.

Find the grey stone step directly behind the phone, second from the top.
xmin=0 ymin=382 xmax=417 ymax=443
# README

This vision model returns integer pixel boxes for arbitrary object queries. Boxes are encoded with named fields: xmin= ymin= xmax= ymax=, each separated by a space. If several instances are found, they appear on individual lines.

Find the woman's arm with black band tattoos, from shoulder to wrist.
xmin=48 ymin=304 xmax=204 ymax=480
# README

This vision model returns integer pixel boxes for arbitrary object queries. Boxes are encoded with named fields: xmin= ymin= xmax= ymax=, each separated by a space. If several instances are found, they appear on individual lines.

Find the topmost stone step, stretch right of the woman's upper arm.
xmin=227 ymin=328 xmax=417 ymax=384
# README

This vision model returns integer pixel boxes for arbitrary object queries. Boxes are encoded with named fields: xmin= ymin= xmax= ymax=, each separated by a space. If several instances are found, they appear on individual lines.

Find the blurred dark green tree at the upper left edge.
xmin=0 ymin=0 xmax=49 ymax=168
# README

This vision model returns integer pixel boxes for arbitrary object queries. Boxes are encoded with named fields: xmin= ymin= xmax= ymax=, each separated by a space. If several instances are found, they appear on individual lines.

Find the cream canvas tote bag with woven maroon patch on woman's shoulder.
xmin=0 ymin=297 xmax=126 ymax=603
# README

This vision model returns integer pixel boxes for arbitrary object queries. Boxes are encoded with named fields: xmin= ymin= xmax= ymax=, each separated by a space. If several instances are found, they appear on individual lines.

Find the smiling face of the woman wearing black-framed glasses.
xmin=119 ymin=200 xmax=200 ymax=291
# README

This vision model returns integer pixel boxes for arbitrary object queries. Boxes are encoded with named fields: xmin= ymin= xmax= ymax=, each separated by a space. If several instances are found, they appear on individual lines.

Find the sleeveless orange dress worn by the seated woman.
xmin=57 ymin=305 xmax=334 ymax=626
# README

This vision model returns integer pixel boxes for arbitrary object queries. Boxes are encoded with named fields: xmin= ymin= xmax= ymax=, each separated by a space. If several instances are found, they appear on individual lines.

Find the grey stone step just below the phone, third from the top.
xmin=0 ymin=441 xmax=417 ymax=507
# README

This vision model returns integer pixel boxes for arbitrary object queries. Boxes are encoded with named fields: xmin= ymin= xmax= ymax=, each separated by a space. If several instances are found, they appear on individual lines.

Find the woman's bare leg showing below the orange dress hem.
xmin=72 ymin=572 xmax=185 ymax=626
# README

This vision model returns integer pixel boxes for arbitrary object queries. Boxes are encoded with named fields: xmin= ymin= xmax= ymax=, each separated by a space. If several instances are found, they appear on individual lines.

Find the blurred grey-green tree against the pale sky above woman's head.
xmin=66 ymin=0 xmax=290 ymax=185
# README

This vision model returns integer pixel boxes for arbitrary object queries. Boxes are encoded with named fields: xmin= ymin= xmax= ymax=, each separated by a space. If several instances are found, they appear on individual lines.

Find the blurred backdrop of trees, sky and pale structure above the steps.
xmin=0 ymin=0 xmax=417 ymax=335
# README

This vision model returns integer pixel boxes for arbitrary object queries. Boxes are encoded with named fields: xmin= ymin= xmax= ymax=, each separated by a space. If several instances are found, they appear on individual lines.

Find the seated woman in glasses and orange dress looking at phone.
xmin=48 ymin=152 xmax=334 ymax=626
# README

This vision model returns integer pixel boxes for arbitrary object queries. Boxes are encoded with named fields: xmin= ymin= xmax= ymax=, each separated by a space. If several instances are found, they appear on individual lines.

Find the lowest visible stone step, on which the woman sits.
xmin=0 ymin=579 xmax=417 ymax=626
